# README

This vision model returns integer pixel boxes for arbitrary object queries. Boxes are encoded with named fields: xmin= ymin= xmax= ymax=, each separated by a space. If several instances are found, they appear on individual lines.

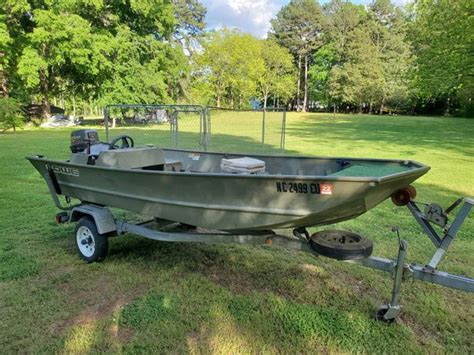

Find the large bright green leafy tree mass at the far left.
xmin=7 ymin=0 xmax=185 ymax=114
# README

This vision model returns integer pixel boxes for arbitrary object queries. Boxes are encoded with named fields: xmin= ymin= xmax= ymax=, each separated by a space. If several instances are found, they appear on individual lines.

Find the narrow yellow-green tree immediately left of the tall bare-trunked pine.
xmin=258 ymin=40 xmax=296 ymax=109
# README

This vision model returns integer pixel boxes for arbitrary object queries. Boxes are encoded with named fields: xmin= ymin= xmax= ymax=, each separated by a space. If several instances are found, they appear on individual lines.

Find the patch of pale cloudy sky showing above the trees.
xmin=201 ymin=0 xmax=406 ymax=38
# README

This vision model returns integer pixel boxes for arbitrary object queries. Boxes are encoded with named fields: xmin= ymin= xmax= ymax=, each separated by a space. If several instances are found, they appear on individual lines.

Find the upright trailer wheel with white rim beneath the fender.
xmin=75 ymin=216 xmax=109 ymax=263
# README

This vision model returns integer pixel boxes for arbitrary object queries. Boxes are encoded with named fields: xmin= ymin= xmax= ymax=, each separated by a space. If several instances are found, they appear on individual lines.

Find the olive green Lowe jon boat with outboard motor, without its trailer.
xmin=27 ymin=130 xmax=429 ymax=231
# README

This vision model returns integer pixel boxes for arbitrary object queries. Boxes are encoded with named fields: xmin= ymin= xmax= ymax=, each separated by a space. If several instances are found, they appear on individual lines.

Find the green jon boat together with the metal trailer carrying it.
xmin=27 ymin=130 xmax=474 ymax=322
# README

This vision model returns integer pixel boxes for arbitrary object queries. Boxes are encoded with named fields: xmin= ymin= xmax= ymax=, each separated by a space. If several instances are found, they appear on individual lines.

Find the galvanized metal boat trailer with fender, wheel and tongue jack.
xmin=48 ymin=192 xmax=474 ymax=323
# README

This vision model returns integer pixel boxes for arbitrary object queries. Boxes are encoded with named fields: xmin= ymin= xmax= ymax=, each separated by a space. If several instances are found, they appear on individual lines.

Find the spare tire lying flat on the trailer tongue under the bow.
xmin=309 ymin=230 xmax=373 ymax=260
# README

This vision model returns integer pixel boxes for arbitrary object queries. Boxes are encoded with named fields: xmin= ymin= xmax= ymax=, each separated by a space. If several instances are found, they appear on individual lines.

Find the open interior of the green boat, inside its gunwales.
xmin=70 ymin=146 xmax=416 ymax=177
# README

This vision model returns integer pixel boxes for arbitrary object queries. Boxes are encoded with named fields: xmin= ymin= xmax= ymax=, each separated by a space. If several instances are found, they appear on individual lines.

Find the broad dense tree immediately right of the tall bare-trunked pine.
xmin=321 ymin=0 xmax=411 ymax=113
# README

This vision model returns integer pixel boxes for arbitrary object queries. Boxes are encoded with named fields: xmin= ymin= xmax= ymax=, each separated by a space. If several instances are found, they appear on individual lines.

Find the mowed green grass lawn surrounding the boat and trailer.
xmin=0 ymin=113 xmax=474 ymax=353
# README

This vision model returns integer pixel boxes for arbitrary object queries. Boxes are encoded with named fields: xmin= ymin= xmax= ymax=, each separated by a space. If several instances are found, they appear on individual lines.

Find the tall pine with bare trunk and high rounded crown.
xmin=270 ymin=0 xmax=323 ymax=111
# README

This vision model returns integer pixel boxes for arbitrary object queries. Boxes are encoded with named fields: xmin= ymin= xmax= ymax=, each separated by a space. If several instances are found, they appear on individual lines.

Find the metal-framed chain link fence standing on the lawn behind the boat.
xmin=104 ymin=105 xmax=286 ymax=153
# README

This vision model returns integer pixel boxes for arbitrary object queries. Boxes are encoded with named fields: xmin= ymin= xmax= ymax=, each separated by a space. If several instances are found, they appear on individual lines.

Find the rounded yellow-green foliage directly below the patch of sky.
xmin=192 ymin=29 xmax=295 ymax=108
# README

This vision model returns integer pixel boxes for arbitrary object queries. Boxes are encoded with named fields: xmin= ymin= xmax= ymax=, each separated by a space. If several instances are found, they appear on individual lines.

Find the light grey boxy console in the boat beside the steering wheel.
xmin=95 ymin=147 xmax=165 ymax=169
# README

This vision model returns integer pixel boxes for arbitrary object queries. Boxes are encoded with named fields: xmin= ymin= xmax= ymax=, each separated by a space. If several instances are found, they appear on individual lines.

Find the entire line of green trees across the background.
xmin=0 ymin=0 xmax=474 ymax=116
